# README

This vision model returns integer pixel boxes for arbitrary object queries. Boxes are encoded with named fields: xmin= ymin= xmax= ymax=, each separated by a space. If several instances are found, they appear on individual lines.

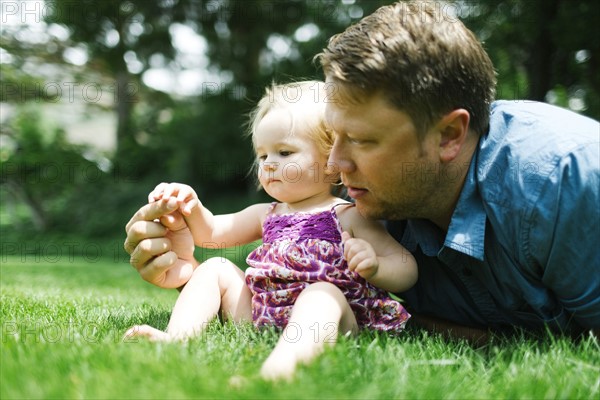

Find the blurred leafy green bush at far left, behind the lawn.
xmin=0 ymin=107 xmax=150 ymax=240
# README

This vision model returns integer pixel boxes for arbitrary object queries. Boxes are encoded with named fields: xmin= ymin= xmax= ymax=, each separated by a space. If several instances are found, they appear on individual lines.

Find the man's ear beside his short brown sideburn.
xmin=436 ymin=108 xmax=470 ymax=163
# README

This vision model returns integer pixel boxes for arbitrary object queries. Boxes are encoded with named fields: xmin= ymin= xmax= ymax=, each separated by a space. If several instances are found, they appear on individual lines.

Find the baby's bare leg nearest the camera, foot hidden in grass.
xmin=261 ymin=282 xmax=358 ymax=379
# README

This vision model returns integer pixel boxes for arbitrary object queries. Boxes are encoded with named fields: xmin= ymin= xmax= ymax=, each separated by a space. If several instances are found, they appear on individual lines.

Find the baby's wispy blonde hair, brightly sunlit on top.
xmin=248 ymin=81 xmax=333 ymax=188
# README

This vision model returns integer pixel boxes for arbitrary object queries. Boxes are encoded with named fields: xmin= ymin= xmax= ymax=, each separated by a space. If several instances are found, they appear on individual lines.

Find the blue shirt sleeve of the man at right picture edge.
xmin=524 ymin=143 xmax=600 ymax=328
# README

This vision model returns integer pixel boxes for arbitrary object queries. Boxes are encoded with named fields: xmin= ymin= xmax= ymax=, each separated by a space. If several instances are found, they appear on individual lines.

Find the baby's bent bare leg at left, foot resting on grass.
xmin=125 ymin=257 xmax=252 ymax=341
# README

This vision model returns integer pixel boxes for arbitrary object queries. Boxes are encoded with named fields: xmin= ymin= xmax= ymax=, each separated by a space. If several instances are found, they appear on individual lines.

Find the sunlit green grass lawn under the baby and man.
xmin=0 ymin=248 xmax=600 ymax=399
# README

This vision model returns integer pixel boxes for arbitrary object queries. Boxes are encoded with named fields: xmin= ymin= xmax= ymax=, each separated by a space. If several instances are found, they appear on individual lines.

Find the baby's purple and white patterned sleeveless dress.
xmin=246 ymin=203 xmax=410 ymax=332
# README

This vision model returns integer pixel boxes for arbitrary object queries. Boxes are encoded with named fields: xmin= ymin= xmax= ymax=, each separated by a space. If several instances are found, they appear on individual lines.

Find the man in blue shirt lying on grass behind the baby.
xmin=127 ymin=2 xmax=600 ymax=335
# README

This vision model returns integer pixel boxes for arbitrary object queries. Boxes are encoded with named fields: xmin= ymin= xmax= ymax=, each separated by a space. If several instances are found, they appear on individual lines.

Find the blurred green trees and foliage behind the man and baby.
xmin=0 ymin=0 xmax=600 ymax=240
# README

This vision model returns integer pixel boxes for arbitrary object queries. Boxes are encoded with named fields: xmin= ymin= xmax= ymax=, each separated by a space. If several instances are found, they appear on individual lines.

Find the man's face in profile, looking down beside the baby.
xmin=326 ymin=94 xmax=440 ymax=219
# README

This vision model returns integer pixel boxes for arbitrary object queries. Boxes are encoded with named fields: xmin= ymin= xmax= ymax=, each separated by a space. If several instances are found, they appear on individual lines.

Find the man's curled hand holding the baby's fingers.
xmin=125 ymin=199 xmax=198 ymax=288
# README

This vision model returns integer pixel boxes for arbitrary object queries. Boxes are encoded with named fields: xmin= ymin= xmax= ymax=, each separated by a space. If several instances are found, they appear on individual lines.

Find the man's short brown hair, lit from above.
xmin=316 ymin=1 xmax=496 ymax=135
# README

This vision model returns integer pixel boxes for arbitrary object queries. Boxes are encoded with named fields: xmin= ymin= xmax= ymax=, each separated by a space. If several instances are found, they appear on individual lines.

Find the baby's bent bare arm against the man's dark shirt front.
xmin=340 ymin=208 xmax=417 ymax=293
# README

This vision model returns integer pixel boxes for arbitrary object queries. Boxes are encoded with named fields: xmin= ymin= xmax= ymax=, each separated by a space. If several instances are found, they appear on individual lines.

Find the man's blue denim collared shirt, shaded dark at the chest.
xmin=387 ymin=101 xmax=600 ymax=330
